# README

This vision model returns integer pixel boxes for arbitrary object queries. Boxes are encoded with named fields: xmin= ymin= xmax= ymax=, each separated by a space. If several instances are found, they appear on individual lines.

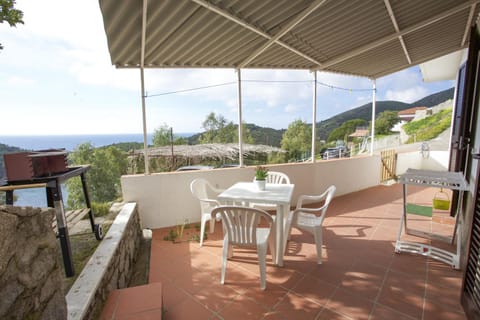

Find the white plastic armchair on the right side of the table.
xmin=287 ymin=185 xmax=337 ymax=264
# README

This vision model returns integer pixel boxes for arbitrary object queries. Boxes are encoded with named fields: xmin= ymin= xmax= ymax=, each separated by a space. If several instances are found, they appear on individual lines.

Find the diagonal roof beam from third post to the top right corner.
xmin=314 ymin=0 xmax=480 ymax=71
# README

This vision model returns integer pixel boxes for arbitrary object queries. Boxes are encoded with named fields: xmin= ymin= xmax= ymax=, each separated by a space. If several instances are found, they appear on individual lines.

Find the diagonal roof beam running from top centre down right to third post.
xmin=191 ymin=0 xmax=326 ymax=68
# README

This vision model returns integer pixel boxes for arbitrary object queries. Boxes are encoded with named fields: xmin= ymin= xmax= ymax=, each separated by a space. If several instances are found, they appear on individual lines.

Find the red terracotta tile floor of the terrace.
xmin=104 ymin=184 xmax=466 ymax=320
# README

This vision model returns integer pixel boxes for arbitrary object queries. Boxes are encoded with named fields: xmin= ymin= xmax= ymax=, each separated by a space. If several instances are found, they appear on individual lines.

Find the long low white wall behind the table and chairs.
xmin=121 ymin=156 xmax=380 ymax=228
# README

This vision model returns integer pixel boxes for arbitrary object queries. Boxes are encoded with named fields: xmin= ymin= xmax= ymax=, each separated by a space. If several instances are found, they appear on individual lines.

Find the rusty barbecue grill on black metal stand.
xmin=0 ymin=149 xmax=103 ymax=277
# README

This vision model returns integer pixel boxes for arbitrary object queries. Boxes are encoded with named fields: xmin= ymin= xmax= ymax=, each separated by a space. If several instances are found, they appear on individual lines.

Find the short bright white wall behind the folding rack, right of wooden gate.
xmin=396 ymin=151 xmax=450 ymax=175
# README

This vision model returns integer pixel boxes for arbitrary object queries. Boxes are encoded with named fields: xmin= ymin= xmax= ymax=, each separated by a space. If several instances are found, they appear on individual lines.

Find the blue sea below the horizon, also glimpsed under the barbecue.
xmin=0 ymin=132 xmax=195 ymax=208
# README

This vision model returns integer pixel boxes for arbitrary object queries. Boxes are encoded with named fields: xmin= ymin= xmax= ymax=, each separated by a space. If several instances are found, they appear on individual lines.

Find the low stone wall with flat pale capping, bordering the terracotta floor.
xmin=66 ymin=203 xmax=142 ymax=320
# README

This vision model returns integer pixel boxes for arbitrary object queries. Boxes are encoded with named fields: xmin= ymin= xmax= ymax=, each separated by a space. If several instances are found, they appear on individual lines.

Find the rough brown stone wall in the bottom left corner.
xmin=0 ymin=206 xmax=67 ymax=320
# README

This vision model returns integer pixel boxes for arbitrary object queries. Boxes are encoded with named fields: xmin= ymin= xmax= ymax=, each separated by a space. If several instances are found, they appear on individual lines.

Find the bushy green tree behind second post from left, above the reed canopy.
xmin=199 ymin=112 xmax=253 ymax=143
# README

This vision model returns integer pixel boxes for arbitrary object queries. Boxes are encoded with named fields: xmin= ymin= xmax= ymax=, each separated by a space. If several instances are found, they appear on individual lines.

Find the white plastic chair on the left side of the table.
xmin=190 ymin=178 xmax=223 ymax=247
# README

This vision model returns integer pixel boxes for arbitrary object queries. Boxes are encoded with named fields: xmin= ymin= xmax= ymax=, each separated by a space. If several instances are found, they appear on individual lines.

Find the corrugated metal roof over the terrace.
xmin=99 ymin=0 xmax=480 ymax=78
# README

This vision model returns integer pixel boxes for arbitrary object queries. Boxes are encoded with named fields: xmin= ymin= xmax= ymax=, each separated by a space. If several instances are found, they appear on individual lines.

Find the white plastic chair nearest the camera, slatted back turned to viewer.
xmin=212 ymin=206 xmax=275 ymax=290
